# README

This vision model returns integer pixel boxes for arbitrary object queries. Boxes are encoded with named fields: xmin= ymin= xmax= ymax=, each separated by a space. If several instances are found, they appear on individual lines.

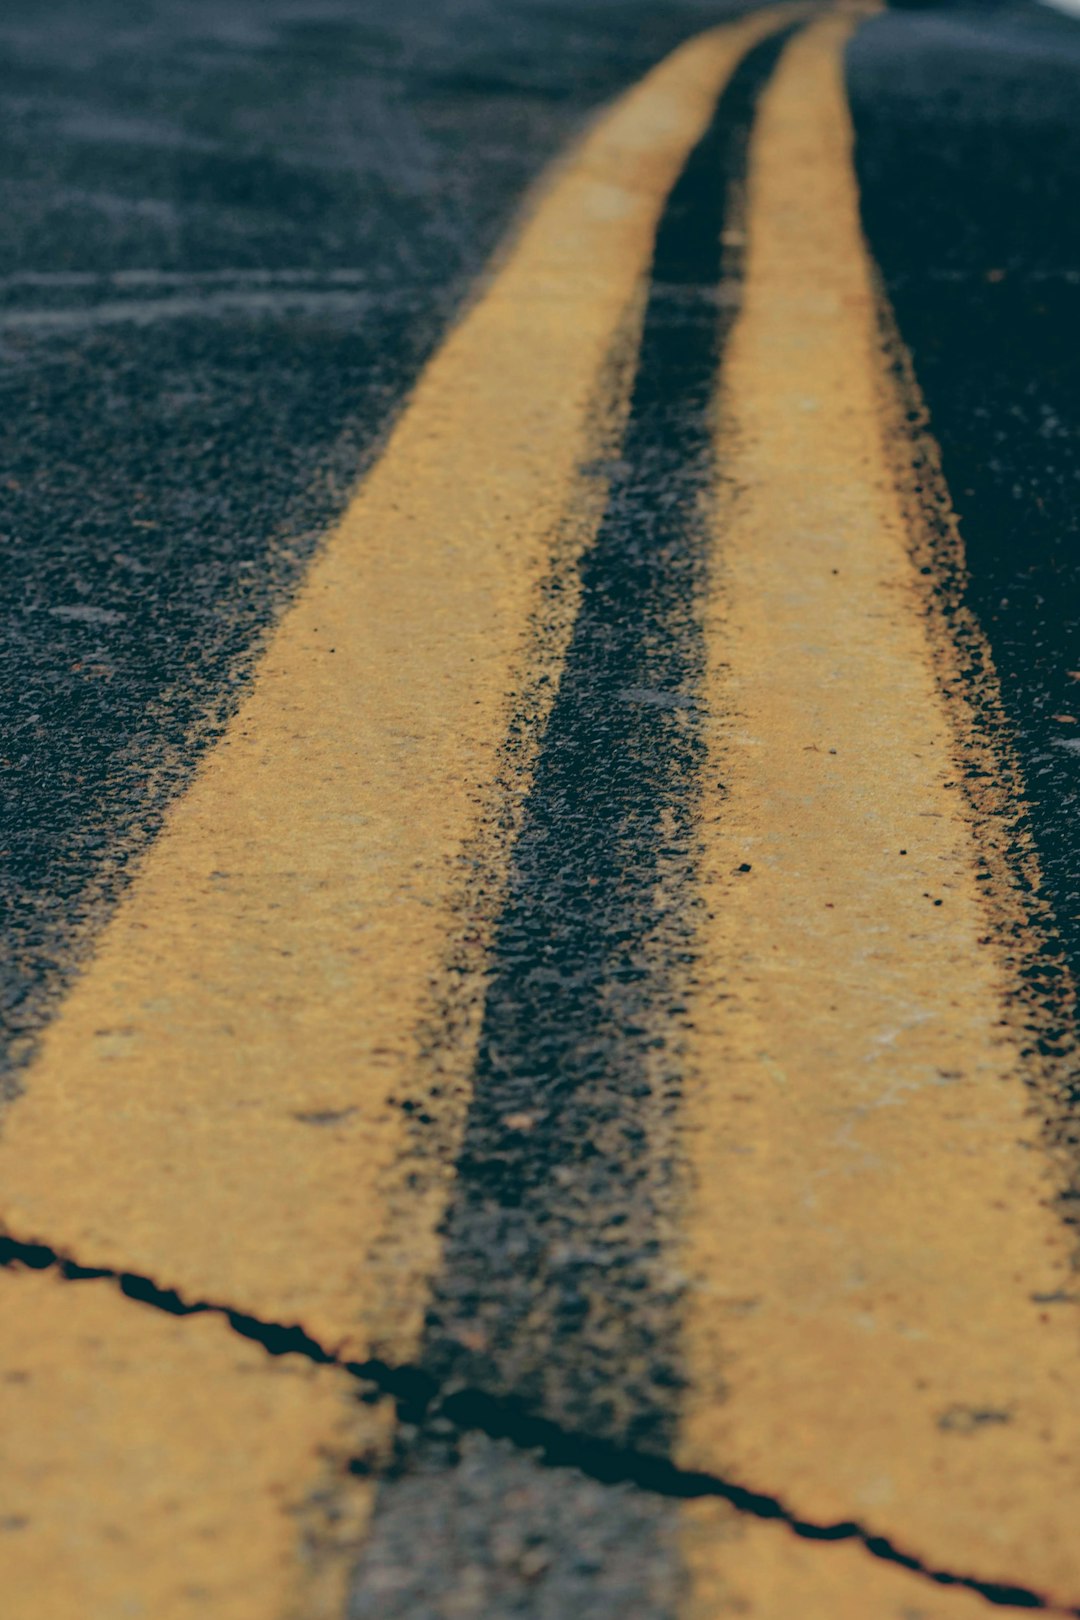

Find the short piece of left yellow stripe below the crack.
xmin=0 ymin=1270 xmax=389 ymax=1620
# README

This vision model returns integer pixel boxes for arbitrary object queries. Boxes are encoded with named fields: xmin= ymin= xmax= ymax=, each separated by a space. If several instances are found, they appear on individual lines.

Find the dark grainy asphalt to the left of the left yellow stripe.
xmin=0 ymin=0 xmax=738 ymax=1087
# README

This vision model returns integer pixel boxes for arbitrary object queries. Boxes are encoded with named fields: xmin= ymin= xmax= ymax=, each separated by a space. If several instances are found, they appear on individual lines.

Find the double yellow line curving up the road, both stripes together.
xmin=0 ymin=6 xmax=1080 ymax=1620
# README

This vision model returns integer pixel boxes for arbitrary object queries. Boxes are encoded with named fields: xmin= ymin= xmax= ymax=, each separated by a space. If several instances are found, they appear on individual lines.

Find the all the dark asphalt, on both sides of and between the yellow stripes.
xmin=0 ymin=0 xmax=1080 ymax=1620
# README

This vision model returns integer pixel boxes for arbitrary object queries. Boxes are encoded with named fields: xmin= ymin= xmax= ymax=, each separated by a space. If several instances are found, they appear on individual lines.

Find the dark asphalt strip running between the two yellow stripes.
xmin=353 ymin=36 xmax=787 ymax=1620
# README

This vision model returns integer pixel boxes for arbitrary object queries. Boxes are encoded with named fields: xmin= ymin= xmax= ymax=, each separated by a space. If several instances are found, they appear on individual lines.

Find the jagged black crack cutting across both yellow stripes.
xmin=0 ymin=1236 xmax=1062 ymax=1617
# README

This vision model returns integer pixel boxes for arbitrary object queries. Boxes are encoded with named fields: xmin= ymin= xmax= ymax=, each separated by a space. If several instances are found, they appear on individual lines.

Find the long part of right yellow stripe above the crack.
xmin=680 ymin=16 xmax=1080 ymax=1612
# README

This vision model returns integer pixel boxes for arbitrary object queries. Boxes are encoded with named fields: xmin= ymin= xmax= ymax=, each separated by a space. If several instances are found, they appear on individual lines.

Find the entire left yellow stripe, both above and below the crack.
xmin=0 ymin=6 xmax=790 ymax=1620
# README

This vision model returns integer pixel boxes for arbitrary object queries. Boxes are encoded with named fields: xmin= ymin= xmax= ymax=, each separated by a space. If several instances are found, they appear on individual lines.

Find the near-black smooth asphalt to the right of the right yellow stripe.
xmin=847 ymin=3 xmax=1080 ymax=1153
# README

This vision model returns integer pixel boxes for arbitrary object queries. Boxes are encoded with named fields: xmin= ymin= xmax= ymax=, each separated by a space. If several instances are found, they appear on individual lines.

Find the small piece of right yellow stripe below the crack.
xmin=680 ymin=1500 xmax=993 ymax=1620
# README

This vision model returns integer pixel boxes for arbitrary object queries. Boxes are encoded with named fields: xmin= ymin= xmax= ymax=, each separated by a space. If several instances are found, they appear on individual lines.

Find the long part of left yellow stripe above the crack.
xmin=0 ymin=8 xmax=799 ymax=1358
